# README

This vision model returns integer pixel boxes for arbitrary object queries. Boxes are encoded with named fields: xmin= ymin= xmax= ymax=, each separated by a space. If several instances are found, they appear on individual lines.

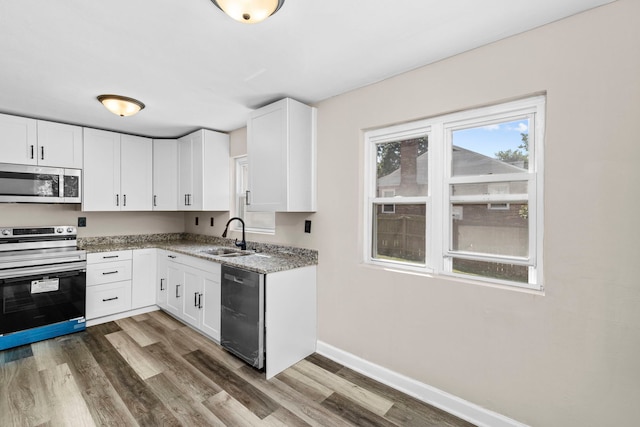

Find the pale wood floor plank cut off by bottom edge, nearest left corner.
xmin=40 ymin=363 xmax=96 ymax=427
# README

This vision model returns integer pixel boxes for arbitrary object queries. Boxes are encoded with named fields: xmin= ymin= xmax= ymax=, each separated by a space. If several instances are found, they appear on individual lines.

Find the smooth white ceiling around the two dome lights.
xmin=0 ymin=0 xmax=611 ymax=137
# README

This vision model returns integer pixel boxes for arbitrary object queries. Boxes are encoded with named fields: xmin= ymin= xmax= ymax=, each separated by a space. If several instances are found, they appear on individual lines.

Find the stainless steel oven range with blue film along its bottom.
xmin=0 ymin=226 xmax=87 ymax=350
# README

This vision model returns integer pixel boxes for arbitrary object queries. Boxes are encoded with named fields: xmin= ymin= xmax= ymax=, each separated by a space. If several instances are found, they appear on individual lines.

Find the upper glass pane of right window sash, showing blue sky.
xmin=451 ymin=118 xmax=529 ymax=176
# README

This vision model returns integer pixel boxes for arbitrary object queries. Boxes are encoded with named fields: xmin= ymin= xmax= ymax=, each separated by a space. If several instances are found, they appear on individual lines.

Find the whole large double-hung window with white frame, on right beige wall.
xmin=364 ymin=96 xmax=545 ymax=290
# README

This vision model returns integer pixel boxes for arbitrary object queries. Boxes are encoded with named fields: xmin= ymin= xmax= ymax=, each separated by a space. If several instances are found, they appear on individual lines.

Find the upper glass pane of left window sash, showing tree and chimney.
xmin=376 ymin=135 xmax=428 ymax=197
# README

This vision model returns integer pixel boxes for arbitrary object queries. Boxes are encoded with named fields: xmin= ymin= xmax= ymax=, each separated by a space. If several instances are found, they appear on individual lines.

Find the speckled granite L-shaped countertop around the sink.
xmin=78 ymin=233 xmax=318 ymax=274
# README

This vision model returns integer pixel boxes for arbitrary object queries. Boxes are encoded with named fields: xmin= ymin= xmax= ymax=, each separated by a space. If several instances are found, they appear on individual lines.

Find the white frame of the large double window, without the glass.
xmin=363 ymin=95 xmax=546 ymax=291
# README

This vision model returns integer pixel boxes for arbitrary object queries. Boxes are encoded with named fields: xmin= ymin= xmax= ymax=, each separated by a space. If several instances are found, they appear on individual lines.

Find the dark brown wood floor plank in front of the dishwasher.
xmin=184 ymin=350 xmax=279 ymax=419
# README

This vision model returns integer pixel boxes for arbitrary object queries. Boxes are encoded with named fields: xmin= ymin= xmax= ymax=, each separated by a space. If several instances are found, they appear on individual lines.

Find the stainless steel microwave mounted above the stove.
xmin=0 ymin=163 xmax=82 ymax=203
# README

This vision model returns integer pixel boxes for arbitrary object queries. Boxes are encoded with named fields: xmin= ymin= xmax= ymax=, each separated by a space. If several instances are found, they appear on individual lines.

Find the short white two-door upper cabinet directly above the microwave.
xmin=0 ymin=114 xmax=82 ymax=169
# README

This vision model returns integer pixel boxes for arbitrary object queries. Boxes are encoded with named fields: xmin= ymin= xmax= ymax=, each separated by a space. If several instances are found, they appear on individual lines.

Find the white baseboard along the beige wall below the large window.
xmin=316 ymin=341 xmax=526 ymax=427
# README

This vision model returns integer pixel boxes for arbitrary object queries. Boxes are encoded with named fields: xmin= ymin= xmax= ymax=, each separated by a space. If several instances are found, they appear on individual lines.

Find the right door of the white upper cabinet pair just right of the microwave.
xmin=120 ymin=135 xmax=153 ymax=211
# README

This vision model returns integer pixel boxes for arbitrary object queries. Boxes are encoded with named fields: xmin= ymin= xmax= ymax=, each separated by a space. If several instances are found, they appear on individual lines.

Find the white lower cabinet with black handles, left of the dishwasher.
xmin=164 ymin=251 xmax=220 ymax=341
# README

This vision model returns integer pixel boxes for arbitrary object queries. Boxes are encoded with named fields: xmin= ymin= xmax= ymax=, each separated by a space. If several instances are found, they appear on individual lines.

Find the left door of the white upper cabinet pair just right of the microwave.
xmin=82 ymin=128 xmax=121 ymax=211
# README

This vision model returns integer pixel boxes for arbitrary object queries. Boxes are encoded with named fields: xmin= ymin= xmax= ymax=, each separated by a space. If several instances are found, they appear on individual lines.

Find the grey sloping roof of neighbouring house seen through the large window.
xmin=378 ymin=146 xmax=526 ymax=187
